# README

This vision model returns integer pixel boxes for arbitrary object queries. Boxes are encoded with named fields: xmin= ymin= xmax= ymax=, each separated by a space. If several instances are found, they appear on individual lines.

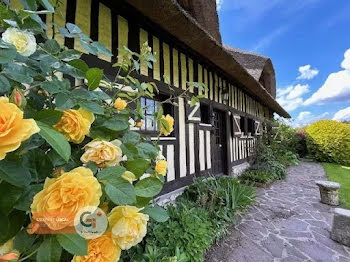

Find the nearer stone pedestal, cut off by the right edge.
xmin=331 ymin=208 xmax=350 ymax=247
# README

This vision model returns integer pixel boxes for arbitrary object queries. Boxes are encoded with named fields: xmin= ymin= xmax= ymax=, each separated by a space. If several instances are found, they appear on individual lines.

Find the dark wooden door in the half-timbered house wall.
xmin=212 ymin=110 xmax=227 ymax=174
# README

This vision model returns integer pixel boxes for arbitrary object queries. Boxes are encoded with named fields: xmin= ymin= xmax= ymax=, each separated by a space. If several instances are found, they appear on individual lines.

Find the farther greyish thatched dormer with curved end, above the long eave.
xmin=224 ymin=45 xmax=276 ymax=98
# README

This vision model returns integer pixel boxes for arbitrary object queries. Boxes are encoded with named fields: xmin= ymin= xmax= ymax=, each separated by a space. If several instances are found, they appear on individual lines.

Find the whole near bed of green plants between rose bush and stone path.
xmin=122 ymin=177 xmax=255 ymax=262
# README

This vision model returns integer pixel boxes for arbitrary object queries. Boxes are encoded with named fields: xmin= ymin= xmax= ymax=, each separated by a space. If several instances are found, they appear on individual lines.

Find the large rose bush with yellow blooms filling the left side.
xmin=0 ymin=0 xmax=203 ymax=262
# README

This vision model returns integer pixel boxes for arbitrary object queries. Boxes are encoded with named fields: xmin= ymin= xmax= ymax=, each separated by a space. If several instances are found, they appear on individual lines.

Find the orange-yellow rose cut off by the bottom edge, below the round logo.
xmin=72 ymin=232 xmax=121 ymax=262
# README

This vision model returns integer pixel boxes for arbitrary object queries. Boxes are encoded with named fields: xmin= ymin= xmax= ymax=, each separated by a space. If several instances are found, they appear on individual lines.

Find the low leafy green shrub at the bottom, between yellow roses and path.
xmin=122 ymin=200 xmax=214 ymax=262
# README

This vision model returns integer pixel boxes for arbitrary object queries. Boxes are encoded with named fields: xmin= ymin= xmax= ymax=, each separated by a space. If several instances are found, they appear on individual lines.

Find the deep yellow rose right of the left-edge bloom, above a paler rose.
xmin=54 ymin=109 xmax=95 ymax=144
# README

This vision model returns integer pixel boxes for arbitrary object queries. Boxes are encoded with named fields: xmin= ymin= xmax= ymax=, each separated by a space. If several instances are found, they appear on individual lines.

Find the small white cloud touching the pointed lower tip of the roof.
xmin=277 ymin=84 xmax=309 ymax=111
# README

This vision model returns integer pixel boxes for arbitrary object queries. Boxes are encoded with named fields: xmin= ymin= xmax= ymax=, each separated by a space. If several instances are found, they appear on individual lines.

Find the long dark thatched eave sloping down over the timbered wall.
xmin=127 ymin=0 xmax=290 ymax=118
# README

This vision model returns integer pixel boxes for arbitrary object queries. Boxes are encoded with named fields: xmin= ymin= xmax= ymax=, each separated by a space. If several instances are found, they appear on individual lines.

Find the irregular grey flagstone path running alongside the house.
xmin=206 ymin=162 xmax=350 ymax=262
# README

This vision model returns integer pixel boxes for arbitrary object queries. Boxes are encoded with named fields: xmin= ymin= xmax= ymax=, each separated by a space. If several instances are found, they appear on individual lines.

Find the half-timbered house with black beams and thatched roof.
xmin=39 ymin=0 xmax=290 ymax=193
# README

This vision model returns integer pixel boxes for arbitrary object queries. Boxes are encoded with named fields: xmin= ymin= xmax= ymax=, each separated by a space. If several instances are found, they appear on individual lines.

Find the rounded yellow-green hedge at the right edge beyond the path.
xmin=306 ymin=120 xmax=350 ymax=165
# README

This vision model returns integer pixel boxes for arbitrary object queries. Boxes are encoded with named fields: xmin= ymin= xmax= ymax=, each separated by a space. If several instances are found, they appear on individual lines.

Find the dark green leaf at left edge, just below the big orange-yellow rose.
xmin=0 ymin=160 xmax=31 ymax=187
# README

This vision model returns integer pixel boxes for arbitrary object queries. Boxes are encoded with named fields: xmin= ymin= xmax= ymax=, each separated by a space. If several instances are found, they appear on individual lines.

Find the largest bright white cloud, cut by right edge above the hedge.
xmin=304 ymin=49 xmax=350 ymax=105
